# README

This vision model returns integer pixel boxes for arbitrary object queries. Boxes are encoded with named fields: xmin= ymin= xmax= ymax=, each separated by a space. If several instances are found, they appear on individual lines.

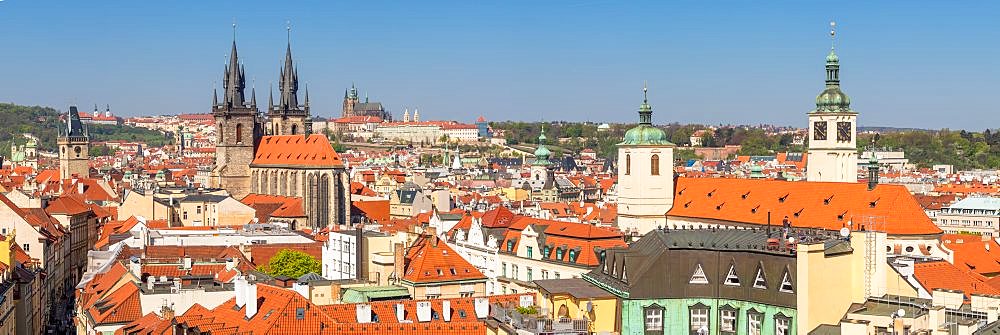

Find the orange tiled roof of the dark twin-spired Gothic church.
xmin=250 ymin=134 xmax=344 ymax=168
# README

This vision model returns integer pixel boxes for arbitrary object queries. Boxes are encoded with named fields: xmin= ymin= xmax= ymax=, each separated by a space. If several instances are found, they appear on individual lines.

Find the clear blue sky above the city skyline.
xmin=0 ymin=0 xmax=1000 ymax=130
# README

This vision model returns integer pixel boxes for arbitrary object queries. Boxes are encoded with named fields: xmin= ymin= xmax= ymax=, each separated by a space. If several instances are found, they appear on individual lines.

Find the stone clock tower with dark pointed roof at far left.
xmin=56 ymin=106 xmax=90 ymax=179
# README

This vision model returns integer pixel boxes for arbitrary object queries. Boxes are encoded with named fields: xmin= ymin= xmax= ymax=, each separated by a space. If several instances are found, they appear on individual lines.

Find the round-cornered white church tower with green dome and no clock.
xmin=616 ymin=85 xmax=675 ymax=236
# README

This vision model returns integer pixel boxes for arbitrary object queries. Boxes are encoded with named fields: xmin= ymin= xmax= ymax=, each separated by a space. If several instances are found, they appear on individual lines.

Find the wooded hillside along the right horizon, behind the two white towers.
xmin=490 ymin=122 xmax=1000 ymax=170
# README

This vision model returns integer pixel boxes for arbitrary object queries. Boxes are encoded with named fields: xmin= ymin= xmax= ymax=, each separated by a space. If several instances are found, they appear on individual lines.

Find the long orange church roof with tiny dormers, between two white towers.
xmin=667 ymin=177 xmax=941 ymax=235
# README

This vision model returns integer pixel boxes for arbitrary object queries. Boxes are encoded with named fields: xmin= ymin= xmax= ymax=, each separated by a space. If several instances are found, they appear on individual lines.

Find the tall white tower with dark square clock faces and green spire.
xmin=806 ymin=22 xmax=858 ymax=183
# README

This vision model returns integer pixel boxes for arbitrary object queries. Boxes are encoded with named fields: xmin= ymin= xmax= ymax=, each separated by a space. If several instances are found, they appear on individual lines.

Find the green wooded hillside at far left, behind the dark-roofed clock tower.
xmin=0 ymin=103 xmax=173 ymax=157
